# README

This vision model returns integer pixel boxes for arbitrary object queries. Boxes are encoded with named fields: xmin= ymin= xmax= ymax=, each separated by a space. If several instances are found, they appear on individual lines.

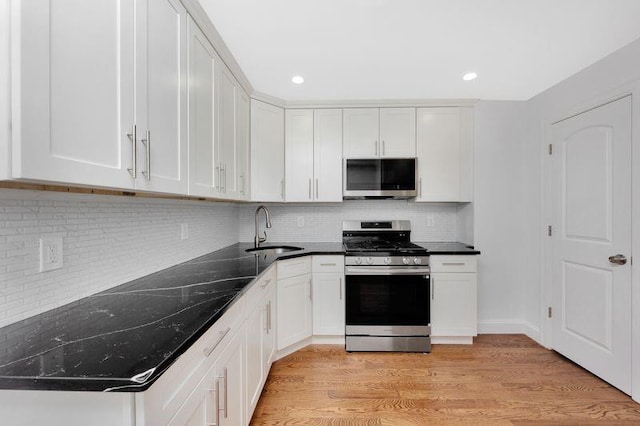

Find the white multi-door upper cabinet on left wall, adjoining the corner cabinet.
xmin=188 ymin=19 xmax=249 ymax=199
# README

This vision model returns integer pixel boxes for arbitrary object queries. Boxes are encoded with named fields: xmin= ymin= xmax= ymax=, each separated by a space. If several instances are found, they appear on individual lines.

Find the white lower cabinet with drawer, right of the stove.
xmin=430 ymin=256 xmax=478 ymax=343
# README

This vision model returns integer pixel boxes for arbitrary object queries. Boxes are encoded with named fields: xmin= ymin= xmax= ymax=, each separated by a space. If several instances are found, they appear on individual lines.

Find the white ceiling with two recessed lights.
xmin=200 ymin=0 xmax=640 ymax=101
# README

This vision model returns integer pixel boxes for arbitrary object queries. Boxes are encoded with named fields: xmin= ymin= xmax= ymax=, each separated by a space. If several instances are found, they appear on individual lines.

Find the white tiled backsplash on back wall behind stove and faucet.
xmin=240 ymin=200 xmax=457 ymax=242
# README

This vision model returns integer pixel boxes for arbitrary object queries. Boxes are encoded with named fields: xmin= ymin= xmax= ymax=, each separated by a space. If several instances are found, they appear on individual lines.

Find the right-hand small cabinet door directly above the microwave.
xmin=380 ymin=108 xmax=416 ymax=158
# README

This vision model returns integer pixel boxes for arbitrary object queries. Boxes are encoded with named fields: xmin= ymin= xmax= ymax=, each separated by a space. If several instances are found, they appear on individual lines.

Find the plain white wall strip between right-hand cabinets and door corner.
xmin=473 ymin=101 xmax=527 ymax=333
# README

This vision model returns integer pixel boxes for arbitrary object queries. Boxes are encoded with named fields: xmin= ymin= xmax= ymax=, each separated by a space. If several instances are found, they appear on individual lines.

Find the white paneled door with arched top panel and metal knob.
xmin=552 ymin=97 xmax=631 ymax=393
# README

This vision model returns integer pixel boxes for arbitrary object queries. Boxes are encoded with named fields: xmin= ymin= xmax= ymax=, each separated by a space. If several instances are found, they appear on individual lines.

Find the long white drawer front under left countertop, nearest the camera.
xmin=143 ymin=297 xmax=245 ymax=424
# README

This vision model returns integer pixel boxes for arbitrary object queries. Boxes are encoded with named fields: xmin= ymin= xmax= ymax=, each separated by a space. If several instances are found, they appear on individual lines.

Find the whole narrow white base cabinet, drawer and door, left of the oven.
xmin=312 ymin=256 xmax=345 ymax=336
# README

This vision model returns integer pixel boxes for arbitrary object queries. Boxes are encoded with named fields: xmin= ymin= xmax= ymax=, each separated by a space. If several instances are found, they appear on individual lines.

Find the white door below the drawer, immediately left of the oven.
xmin=313 ymin=272 xmax=345 ymax=336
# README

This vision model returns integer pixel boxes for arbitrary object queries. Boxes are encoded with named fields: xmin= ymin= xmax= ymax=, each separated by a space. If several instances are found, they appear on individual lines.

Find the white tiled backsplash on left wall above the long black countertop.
xmin=0 ymin=189 xmax=238 ymax=326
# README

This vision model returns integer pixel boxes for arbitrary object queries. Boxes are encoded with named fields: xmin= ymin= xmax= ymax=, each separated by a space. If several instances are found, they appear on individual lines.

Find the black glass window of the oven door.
xmin=346 ymin=275 xmax=429 ymax=325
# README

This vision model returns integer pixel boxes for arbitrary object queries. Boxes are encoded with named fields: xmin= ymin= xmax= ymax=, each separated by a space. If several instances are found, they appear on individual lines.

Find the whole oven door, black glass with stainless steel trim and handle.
xmin=345 ymin=266 xmax=430 ymax=336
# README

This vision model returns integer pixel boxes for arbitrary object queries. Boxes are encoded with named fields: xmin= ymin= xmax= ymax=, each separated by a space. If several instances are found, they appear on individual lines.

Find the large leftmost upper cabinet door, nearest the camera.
xmin=11 ymin=0 xmax=135 ymax=188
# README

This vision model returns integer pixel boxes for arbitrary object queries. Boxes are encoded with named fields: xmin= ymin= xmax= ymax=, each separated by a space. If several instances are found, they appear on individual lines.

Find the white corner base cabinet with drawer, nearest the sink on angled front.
xmin=277 ymin=256 xmax=313 ymax=350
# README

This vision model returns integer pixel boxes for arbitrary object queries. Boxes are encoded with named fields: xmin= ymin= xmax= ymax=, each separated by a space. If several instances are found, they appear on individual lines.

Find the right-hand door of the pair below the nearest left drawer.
xmin=215 ymin=333 xmax=246 ymax=426
